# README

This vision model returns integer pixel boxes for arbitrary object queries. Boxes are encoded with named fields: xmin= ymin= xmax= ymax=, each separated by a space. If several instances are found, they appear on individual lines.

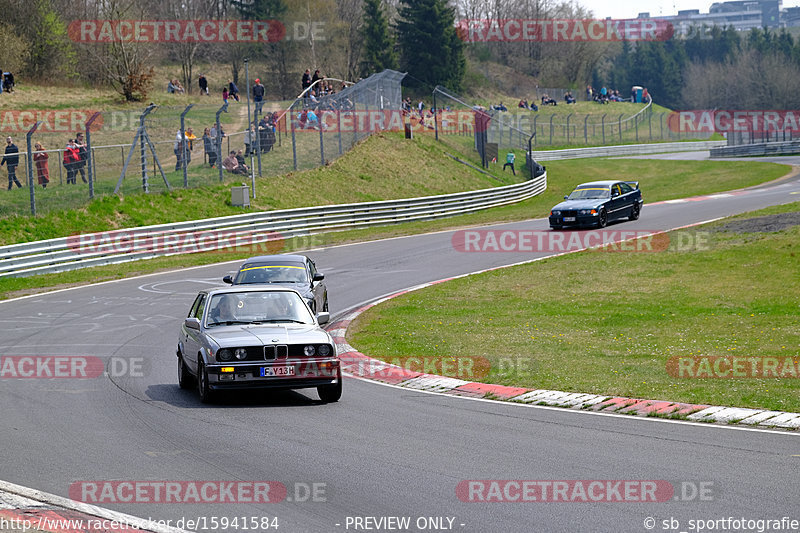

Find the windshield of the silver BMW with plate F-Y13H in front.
xmin=206 ymin=291 xmax=314 ymax=327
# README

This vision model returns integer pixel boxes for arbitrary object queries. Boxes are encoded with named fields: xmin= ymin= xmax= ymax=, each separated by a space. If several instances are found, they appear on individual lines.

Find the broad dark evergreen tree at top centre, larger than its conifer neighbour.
xmin=396 ymin=0 xmax=466 ymax=91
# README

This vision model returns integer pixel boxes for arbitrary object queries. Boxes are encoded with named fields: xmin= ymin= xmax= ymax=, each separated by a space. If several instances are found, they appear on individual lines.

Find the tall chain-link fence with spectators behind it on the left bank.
xmin=0 ymin=70 xmax=404 ymax=216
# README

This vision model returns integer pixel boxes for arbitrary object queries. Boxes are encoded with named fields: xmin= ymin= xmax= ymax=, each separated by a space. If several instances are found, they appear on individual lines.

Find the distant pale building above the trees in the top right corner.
xmin=638 ymin=0 xmax=788 ymax=35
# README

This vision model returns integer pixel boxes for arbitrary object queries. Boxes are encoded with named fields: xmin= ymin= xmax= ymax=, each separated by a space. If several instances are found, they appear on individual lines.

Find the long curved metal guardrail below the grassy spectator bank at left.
xmin=0 ymin=173 xmax=547 ymax=278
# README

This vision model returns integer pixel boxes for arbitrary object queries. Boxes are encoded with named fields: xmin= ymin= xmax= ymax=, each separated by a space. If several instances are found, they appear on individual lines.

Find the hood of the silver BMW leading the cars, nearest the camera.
xmin=207 ymin=324 xmax=331 ymax=348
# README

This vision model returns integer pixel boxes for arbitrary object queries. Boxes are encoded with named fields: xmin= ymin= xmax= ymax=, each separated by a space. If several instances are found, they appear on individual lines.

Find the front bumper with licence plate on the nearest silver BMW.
xmin=206 ymin=357 xmax=342 ymax=390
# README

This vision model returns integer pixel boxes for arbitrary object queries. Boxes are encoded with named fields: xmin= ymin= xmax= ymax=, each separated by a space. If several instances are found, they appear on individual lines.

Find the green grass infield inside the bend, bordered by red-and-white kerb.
xmin=348 ymin=203 xmax=800 ymax=412
